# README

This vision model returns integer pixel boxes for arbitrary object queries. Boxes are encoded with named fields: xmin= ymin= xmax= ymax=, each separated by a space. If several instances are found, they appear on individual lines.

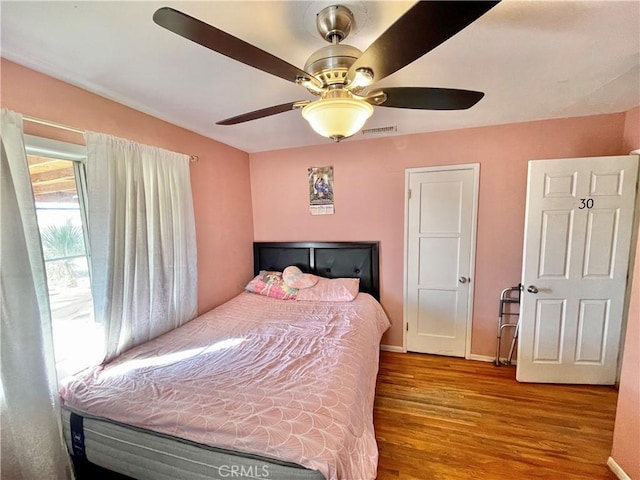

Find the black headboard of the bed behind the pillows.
xmin=253 ymin=242 xmax=380 ymax=300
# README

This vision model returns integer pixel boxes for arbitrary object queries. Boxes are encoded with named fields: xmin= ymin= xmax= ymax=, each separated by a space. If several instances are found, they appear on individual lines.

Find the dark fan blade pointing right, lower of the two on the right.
xmin=374 ymin=87 xmax=484 ymax=110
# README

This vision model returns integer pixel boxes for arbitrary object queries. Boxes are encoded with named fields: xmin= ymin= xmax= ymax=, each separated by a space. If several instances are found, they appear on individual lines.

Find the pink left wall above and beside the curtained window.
xmin=1 ymin=59 xmax=253 ymax=312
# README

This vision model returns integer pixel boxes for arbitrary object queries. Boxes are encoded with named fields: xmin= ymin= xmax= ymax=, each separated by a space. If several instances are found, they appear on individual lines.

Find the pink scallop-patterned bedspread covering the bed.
xmin=61 ymin=292 xmax=389 ymax=480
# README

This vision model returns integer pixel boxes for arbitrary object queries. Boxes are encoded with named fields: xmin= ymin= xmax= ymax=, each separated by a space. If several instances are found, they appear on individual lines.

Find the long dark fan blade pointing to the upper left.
xmin=153 ymin=7 xmax=311 ymax=82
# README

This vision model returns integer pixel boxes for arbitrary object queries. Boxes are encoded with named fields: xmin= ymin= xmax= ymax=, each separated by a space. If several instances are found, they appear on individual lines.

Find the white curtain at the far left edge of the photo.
xmin=0 ymin=108 xmax=72 ymax=480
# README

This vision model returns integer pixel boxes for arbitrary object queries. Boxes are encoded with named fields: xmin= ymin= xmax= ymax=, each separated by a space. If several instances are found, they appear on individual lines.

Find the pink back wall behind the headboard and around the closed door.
xmin=251 ymin=114 xmax=625 ymax=356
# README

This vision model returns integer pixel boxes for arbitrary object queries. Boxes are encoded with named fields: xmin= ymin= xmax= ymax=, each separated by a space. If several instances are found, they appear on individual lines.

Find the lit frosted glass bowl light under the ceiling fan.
xmin=302 ymin=98 xmax=373 ymax=142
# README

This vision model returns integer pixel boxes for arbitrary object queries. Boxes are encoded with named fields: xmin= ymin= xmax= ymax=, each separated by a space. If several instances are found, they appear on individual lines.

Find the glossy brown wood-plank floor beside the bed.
xmin=374 ymin=352 xmax=617 ymax=480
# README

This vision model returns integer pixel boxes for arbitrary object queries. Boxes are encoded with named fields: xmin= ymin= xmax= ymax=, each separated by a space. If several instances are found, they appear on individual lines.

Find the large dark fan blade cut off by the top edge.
xmin=347 ymin=0 xmax=499 ymax=82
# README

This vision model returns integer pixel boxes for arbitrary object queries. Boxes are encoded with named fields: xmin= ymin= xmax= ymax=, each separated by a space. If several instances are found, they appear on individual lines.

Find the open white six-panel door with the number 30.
xmin=517 ymin=156 xmax=638 ymax=384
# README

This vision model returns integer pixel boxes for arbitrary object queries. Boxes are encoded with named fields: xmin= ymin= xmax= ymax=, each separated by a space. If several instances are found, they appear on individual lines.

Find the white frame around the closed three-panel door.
xmin=402 ymin=163 xmax=480 ymax=359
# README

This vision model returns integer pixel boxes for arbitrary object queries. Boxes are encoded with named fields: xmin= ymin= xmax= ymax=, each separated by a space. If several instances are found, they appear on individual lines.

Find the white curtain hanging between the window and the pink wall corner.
xmin=85 ymin=132 xmax=197 ymax=360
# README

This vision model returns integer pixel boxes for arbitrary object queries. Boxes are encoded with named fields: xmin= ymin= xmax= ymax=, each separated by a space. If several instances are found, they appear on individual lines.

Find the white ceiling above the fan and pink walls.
xmin=0 ymin=0 xmax=640 ymax=153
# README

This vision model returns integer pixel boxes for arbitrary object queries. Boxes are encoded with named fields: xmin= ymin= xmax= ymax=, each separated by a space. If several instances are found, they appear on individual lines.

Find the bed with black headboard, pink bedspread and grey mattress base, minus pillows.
xmin=60 ymin=242 xmax=389 ymax=480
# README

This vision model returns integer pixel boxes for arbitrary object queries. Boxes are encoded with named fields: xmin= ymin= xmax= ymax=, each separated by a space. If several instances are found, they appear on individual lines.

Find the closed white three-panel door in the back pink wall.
xmin=405 ymin=164 xmax=479 ymax=357
